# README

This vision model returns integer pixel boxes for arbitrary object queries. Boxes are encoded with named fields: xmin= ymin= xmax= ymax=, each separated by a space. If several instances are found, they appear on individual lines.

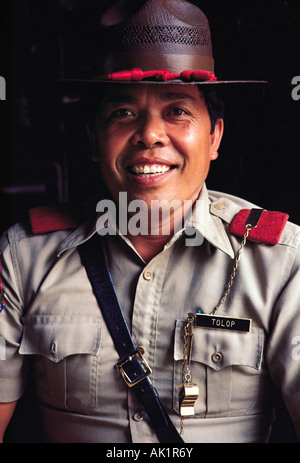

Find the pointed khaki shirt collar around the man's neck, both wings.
xmin=58 ymin=184 xmax=234 ymax=258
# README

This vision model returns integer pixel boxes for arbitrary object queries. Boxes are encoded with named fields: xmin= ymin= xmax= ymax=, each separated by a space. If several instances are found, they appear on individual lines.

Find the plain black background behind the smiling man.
xmin=0 ymin=0 xmax=300 ymax=441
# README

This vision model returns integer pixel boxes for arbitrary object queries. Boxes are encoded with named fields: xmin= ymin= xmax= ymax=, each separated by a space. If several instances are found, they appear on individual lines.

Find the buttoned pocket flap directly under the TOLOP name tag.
xmin=174 ymin=320 xmax=264 ymax=370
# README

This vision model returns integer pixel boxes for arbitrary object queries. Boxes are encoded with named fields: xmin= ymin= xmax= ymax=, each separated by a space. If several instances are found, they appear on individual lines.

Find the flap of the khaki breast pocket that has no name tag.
xmin=19 ymin=315 xmax=100 ymax=362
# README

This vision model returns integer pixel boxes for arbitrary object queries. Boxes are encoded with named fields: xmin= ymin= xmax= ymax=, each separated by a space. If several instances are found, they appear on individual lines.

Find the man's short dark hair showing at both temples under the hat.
xmin=82 ymin=85 xmax=225 ymax=133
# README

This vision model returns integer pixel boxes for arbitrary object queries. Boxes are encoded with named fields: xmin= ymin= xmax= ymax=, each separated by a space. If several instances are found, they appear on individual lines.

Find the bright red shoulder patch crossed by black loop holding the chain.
xmin=229 ymin=209 xmax=289 ymax=245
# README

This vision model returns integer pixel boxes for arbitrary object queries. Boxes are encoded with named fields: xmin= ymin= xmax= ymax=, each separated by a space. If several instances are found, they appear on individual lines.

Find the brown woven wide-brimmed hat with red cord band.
xmin=59 ymin=0 xmax=265 ymax=84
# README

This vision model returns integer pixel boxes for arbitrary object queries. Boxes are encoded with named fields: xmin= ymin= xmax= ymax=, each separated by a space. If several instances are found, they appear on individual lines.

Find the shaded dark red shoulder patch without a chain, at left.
xmin=29 ymin=204 xmax=80 ymax=234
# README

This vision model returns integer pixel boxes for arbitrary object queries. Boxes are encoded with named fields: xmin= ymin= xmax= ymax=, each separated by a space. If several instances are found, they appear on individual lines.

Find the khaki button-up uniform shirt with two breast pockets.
xmin=0 ymin=186 xmax=300 ymax=443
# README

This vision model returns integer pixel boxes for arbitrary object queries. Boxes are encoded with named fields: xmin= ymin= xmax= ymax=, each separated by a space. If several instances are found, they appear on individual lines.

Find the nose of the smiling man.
xmin=131 ymin=114 xmax=168 ymax=149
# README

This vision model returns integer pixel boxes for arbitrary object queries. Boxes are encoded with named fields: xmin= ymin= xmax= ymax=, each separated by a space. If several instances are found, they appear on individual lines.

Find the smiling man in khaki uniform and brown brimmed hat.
xmin=0 ymin=0 xmax=300 ymax=443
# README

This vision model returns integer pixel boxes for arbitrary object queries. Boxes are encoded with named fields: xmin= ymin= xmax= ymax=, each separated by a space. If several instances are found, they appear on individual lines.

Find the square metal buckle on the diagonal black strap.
xmin=116 ymin=348 xmax=152 ymax=387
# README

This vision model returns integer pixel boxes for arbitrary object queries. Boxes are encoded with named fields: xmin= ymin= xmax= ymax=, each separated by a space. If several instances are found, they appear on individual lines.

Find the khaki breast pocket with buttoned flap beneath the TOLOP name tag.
xmin=173 ymin=320 xmax=266 ymax=418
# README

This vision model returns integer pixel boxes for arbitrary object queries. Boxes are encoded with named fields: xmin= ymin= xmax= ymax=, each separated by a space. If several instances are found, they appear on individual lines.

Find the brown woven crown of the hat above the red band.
xmin=100 ymin=0 xmax=214 ymax=73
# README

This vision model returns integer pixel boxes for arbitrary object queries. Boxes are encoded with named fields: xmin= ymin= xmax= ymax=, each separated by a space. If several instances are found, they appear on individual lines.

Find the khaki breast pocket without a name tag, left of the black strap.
xmin=19 ymin=315 xmax=101 ymax=413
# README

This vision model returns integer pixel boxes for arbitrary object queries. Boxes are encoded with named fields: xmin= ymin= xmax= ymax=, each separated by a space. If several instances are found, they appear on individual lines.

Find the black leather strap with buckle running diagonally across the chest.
xmin=77 ymin=234 xmax=184 ymax=444
